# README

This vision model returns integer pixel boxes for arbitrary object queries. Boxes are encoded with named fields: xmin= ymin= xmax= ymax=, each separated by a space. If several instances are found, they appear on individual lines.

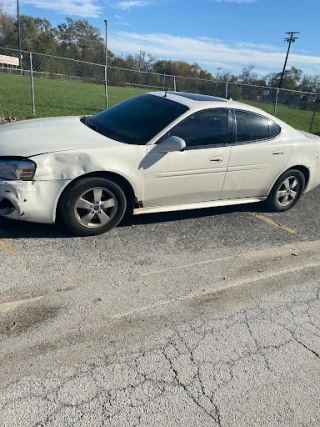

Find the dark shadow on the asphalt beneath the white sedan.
xmin=0 ymin=203 xmax=270 ymax=239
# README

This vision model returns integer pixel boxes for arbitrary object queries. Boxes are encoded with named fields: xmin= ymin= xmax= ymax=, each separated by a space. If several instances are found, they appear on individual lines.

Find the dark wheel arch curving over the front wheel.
xmin=56 ymin=171 xmax=138 ymax=217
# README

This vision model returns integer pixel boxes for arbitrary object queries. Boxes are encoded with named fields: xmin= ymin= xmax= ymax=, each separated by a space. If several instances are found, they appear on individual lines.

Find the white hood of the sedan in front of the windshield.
xmin=0 ymin=116 xmax=123 ymax=157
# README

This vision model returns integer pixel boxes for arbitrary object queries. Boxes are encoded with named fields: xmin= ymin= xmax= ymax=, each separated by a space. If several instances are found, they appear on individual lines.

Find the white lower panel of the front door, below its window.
xmin=143 ymin=146 xmax=231 ymax=207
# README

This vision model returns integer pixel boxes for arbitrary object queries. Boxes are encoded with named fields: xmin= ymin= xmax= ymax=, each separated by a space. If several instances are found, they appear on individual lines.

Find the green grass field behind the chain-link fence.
xmin=0 ymin=73 xmax=320 ymax=133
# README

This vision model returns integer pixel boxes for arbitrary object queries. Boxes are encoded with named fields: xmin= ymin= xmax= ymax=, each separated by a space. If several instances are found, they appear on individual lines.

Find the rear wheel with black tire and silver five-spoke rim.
xmin=265 ymin=169 xmax=306 ymax=212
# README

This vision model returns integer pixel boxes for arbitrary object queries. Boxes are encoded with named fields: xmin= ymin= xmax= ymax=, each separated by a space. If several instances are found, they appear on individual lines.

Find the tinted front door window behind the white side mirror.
xmin=169 ymin=108 xmax=228 ymax=147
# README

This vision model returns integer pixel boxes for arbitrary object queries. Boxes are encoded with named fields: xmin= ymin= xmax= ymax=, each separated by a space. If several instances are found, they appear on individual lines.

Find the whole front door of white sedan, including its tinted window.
xmin=143 ymin=109 xmax=231 ymax=207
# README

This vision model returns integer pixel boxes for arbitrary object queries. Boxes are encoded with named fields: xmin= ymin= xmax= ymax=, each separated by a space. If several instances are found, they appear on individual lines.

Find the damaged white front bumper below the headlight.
xmin=0 ymin=180 xmax=70 ymax=224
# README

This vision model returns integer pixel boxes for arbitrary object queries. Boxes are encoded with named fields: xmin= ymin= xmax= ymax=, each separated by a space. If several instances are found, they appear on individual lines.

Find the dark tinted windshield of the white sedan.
xmin=81 ymin=95 xmax=188 ymax=145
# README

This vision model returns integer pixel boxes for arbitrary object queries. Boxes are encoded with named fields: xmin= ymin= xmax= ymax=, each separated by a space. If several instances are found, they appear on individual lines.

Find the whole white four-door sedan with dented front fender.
xmin=0 ymin=92 xmax=320 ymax=236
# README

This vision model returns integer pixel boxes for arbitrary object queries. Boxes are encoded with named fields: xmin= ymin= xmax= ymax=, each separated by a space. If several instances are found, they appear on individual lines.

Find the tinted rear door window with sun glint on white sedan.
xmin=236 ymin=111 xmax=281 ymax=142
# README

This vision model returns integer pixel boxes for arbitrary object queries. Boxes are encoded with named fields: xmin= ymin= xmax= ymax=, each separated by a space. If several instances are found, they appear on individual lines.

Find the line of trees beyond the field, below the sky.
xmin=0 ymin=3 xmax=320 ymax=92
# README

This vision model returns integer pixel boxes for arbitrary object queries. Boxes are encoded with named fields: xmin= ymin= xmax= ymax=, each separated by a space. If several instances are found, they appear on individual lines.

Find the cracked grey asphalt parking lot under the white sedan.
xmin=0 ymin=189 xmax=320 ymax=427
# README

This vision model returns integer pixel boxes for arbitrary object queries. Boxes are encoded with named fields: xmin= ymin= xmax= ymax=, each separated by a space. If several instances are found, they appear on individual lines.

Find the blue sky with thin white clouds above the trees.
xmin=4 ymin=0 xmax=320 ymax=77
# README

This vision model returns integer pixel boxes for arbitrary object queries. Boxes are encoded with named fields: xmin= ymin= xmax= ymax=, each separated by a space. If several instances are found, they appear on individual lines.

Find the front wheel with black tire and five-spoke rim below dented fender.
xmin=58 ymin=178 xmax=127 ymax=236
